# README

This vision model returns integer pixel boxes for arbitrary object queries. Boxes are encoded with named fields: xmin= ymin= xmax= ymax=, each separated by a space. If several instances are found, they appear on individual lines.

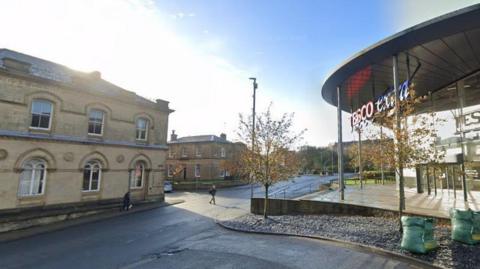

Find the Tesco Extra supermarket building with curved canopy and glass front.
xmin=322 ymin=4 xmax=480 ymax=200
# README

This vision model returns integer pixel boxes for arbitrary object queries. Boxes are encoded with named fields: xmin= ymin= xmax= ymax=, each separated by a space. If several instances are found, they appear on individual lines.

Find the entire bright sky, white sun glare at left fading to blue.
xmin=0 ymin=0 xmax=480 ymax=145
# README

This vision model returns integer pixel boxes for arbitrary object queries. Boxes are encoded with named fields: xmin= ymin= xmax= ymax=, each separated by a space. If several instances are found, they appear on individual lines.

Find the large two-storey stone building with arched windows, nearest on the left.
xmin=0 ymin=49 xmax=173 ymax=210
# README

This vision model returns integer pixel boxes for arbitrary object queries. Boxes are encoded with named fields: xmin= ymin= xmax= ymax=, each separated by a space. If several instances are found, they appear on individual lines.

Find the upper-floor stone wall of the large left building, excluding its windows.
xmin=0 ymin=74 xmax=168 ymax=145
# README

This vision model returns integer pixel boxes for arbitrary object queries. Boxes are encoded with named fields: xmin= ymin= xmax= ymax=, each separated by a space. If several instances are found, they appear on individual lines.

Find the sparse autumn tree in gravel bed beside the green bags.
xmin=368 ymin=88 xmax=443 ymax=230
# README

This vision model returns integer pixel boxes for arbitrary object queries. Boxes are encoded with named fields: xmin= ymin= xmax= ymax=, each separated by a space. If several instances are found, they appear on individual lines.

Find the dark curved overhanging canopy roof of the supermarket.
xmin=322 ymin=4 xmax=480 ymax=112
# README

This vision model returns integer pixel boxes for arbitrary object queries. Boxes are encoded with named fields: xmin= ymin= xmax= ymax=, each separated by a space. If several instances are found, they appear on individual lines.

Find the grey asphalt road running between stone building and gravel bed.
xmin=0 ymin=177 xmax=412 ymax=269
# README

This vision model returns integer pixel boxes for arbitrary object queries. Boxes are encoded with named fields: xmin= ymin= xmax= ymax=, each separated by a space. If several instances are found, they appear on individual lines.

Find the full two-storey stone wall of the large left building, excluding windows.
xmin=0 ymin=59 xmax=171 ymax=210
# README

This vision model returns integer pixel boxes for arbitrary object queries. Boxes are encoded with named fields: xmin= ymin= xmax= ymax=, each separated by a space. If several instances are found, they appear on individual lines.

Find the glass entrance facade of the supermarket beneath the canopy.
xmin=416 ymin=72 xmax=480 ymax=196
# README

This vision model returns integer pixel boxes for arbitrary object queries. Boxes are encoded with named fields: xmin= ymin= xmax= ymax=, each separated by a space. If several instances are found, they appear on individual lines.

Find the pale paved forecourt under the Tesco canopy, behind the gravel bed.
xmin=302 ymin=184 xmax=480 ymax=217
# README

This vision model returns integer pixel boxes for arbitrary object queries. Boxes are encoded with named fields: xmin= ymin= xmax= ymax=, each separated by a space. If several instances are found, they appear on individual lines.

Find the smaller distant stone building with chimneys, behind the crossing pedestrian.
xmin=166 ymin=131 xmax=245 ymax=180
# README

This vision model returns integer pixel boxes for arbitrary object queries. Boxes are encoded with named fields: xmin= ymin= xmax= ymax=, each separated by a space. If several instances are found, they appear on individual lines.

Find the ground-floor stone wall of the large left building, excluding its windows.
xmin=0 ymin=133 xmax=166 ymax=209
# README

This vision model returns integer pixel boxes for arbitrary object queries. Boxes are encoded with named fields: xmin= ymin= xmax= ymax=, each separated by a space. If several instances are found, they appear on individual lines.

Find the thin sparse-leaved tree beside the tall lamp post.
xmin=238 ymin=106 xmax=306 ymax=218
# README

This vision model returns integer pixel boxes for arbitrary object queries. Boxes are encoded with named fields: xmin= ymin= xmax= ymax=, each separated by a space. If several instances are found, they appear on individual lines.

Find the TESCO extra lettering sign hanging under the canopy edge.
xmin=350 ymin=80 xmax=410 ymax=127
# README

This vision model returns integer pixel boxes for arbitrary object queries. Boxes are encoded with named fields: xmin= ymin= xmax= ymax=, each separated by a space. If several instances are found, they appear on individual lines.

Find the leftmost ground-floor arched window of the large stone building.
xmin=18 ymin=159 xmax=47 ymax=196
